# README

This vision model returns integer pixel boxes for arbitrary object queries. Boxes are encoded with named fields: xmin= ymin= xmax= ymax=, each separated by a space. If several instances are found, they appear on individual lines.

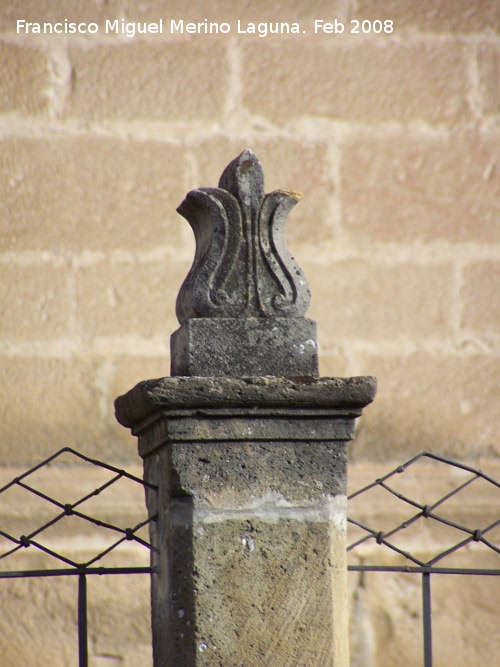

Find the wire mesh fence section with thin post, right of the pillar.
xmin=347 ymin=452 xmax=500 ymax=667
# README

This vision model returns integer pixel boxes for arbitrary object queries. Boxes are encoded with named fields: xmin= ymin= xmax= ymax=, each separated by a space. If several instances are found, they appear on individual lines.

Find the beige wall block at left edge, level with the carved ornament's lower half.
xmin=0 ymin=264 xmax=71 ymax=341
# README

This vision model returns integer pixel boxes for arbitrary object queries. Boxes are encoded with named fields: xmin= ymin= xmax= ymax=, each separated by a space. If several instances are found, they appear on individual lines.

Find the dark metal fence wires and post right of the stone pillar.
xmin=347 ymin=452 xmax=500 ymax=667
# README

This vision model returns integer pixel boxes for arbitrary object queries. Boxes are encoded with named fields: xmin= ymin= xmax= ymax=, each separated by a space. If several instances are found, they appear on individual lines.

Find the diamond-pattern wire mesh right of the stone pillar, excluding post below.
xmin=347 ymin=452 xmax=500 ymax=573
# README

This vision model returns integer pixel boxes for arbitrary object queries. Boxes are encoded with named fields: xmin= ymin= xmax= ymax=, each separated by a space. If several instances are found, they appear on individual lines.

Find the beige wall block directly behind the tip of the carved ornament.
xmin=190 ymin=135 xmax=332 ymax=250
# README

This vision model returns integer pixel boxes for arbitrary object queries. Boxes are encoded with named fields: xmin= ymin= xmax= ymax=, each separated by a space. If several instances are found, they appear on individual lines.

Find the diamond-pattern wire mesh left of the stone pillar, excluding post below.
xmin=0 ymin=447 xmax=156 ymax=578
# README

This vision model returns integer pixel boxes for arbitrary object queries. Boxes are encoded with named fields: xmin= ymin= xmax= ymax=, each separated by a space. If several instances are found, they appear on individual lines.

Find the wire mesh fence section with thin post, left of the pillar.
xmin=0 ymin=447 xmax=156 ymax=667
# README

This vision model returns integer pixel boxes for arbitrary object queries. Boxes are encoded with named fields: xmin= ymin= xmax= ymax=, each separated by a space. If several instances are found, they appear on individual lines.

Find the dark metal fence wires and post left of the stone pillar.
xmin=0 ymin=447 xmax=156 ymax=667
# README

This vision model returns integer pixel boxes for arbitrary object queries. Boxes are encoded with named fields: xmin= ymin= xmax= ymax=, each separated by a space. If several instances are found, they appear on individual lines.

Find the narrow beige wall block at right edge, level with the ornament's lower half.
xmin=461 ymin=261 xmax=500 ymax=335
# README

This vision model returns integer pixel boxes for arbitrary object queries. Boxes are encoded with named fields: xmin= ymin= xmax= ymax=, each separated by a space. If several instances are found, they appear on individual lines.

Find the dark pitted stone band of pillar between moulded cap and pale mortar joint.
xmin=171 ymin=441 xmax=347 ymax=509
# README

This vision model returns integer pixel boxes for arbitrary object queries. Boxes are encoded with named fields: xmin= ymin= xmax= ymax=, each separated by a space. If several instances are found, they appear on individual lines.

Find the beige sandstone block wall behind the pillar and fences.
xmin=0 ymin=0 xmax=500 ymax=667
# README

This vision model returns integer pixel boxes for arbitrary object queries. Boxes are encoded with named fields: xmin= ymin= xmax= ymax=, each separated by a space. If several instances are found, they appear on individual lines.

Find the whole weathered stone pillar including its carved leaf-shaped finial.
xmin=116 ymin=151 xmax=376 ymax=667
